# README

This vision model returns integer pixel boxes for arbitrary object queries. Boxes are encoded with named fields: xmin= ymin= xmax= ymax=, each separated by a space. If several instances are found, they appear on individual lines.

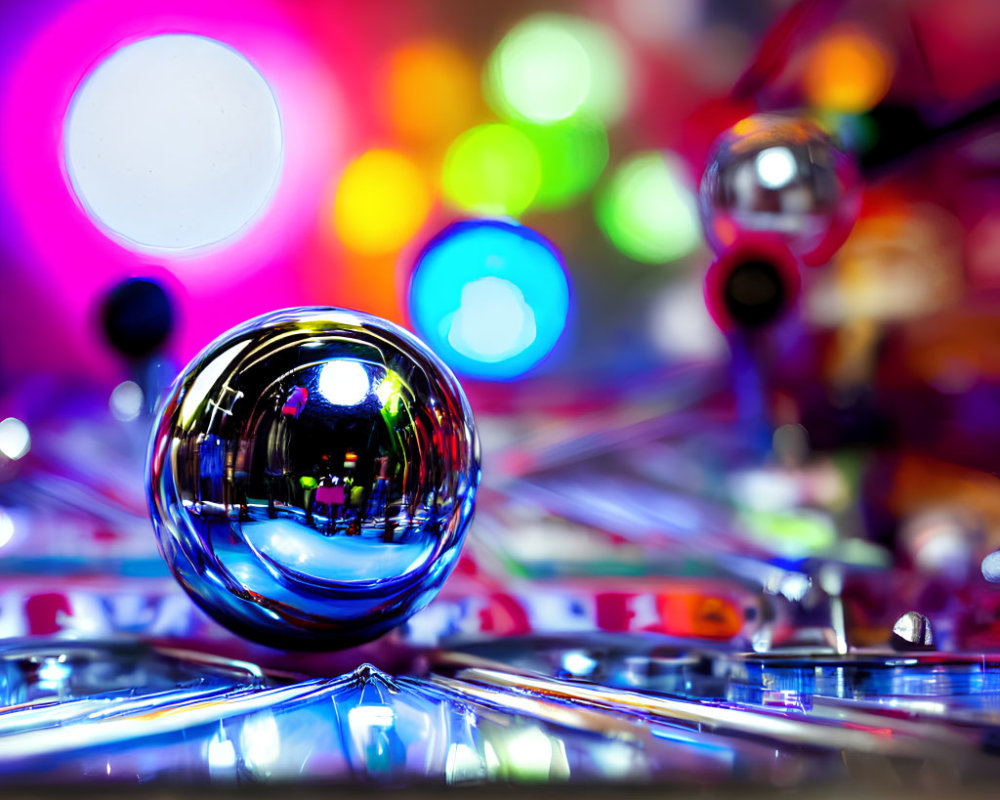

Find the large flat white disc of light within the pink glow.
xmin=64 ymin=35 xmax=282 ymax=251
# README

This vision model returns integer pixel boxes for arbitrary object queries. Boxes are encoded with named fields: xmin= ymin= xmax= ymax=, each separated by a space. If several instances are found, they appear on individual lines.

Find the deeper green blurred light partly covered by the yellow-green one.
xmin=518 ymin=118 xmax=608 ymax=210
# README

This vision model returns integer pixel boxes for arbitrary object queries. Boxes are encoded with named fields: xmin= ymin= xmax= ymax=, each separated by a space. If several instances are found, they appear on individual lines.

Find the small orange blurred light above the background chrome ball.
xmin=803 ymin=26 xmax=893 ymax=114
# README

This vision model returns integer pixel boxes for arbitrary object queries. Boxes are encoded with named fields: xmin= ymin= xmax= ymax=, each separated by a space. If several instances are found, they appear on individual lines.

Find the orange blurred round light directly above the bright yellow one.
xmin=378 ymin=39 xmax=480 ymax=144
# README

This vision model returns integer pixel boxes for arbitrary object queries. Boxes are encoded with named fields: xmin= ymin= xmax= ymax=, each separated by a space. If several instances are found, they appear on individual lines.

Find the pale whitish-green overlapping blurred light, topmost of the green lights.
xmin=485 ymin=14 xmax=631 ymax=124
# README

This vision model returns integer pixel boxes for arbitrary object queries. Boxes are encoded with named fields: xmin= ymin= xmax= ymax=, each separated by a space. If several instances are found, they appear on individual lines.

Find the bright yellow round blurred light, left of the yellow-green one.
xmin=333 ymin=150 xmax=431 ymax=255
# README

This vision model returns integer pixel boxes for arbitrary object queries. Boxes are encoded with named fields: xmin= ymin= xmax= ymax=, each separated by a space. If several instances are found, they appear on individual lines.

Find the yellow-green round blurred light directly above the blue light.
xmin=441 ymin=123 xmax=542 ymax=217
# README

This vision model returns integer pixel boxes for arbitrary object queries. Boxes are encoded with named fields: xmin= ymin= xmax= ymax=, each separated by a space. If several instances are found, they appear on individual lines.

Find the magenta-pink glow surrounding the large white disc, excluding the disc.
xmin=0 ymin=0 xmax=345 ymax=382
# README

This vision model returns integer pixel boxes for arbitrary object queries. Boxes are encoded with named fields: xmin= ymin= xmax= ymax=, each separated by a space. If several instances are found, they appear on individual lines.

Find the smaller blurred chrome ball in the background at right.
xmin=700 ymin=114 xmax=861 ymax=265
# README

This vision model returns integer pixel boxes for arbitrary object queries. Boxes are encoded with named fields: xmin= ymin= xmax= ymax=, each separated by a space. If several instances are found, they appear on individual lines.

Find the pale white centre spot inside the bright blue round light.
xmin=448 ymin=277 xmax=537 ymax=364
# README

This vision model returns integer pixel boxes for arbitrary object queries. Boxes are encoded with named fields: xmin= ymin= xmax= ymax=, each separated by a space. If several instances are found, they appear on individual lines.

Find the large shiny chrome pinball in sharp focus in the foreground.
xmin=147 ymin=308 xmax=480 ymax=650
